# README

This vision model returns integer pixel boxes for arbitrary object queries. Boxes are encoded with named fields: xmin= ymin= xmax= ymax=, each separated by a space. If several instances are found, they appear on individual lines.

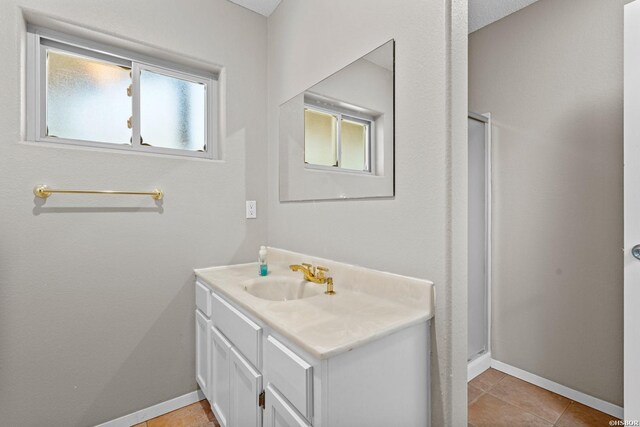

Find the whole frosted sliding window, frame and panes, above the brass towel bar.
xmin=27 ymin=26 xmax=218 ymax=158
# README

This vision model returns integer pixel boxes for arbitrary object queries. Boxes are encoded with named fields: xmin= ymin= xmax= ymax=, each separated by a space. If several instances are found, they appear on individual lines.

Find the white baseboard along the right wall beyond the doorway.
xmin=491 ymin=359 xmax=624 ymax=419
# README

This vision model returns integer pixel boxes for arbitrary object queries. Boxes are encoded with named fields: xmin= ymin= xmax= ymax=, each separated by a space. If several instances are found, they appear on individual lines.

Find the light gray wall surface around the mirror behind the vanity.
xmin=268 ymin=0 xmax=467 ymax=426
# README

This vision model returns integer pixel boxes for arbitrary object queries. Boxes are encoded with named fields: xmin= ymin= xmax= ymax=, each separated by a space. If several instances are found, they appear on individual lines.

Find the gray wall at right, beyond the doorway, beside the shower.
xmin=469 ymin=0 xmax=623 ymax=405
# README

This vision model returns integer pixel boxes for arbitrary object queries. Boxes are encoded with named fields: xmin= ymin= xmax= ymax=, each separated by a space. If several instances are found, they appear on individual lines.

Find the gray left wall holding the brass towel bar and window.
xmin=0 ymin=0 xmax=267 ymax=426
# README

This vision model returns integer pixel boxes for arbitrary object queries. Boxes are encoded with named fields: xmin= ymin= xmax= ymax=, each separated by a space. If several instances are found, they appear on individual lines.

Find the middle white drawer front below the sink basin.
xmin=211 ymin=292 xmax=262 ymax=369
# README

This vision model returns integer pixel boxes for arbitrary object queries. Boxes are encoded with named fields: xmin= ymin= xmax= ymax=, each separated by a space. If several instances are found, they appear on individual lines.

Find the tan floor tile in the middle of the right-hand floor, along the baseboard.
xmin=489 ymin=375 xmax=571 ymax=424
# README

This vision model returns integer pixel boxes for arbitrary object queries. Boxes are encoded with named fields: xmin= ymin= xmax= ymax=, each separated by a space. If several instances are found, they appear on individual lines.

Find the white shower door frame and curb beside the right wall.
xmin=467 ymin=111 xmax=492 ymax=381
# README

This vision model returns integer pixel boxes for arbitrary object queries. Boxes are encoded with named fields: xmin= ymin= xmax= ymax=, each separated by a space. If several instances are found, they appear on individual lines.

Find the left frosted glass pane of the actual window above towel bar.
xmin=46 ymin=49 xmax=131 ymax=144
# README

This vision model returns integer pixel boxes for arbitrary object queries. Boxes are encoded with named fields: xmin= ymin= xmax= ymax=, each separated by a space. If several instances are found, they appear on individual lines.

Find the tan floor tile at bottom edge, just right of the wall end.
xmin=469 ymin=394 xmax=553 ymax=427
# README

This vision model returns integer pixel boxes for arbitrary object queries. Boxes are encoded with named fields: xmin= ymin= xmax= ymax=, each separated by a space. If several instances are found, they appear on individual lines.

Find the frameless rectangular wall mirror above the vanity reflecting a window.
xmin=279 ymin=40 xmax=395 ymax=202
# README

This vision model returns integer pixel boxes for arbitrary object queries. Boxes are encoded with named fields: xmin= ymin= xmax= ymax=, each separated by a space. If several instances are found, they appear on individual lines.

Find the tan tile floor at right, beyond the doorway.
xmin=467 ymin=369 xmax=617 ymax=427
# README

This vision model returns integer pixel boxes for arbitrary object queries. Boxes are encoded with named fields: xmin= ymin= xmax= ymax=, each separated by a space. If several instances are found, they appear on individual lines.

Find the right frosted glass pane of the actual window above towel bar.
xmin=140 ymin=70 xmax=206 ymax=151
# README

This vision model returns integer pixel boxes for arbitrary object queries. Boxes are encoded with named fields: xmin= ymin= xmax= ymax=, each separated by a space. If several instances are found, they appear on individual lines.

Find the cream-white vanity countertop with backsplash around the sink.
xmin=195 ymin=248 xmax=434 ymax=359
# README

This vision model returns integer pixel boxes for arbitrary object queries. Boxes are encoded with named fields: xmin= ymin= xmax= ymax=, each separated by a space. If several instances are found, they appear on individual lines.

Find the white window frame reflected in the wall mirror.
xmin=304 ymin=100 xmax=376 ymax=175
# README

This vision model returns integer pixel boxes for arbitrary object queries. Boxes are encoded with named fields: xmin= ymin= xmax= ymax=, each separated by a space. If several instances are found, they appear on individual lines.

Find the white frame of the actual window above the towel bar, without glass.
xmin=27 ymin=26 xmax=219 ymax=159
